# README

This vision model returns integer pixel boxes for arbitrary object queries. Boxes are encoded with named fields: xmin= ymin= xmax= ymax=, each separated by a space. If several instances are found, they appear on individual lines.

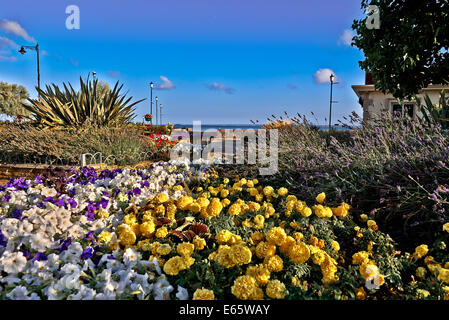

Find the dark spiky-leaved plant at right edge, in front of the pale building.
xmin=416 ymin=91 xmax=449 ymax=129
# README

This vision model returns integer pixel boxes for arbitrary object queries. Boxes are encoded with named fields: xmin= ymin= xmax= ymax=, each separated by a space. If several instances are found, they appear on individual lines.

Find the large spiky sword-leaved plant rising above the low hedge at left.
xmin=23 ymin=77 xmax=145 ymax=128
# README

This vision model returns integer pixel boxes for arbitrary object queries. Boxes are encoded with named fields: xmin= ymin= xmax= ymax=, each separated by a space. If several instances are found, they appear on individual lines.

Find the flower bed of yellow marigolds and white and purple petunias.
xmin=0 ymin=161 xmax=449 ymax=300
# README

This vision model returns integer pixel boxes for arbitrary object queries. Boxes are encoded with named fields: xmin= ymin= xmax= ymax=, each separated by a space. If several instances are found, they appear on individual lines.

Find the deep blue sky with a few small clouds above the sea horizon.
xmin=0 ymin=0 xmax=364 ymax=124
